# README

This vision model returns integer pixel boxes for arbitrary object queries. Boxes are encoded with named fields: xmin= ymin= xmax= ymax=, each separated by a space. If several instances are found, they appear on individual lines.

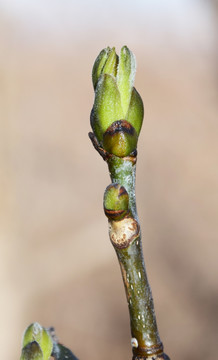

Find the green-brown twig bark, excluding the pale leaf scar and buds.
xmin=107 ymin=156 xmax=163 ymax=356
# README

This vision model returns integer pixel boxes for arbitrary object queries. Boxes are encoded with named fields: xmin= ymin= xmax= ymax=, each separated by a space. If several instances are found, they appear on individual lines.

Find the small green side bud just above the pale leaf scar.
xmin=104 ymin=183 xmax=129 ymax=221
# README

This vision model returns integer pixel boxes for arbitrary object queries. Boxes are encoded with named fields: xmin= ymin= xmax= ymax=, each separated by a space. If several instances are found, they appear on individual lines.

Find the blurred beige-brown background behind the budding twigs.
xmin=0 ymin=0 xmax=218 ymax=360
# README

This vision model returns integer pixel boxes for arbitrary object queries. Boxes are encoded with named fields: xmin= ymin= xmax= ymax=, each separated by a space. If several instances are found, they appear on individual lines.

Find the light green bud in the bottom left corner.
xmin=23 ymin=322 xmax=53 ymax=360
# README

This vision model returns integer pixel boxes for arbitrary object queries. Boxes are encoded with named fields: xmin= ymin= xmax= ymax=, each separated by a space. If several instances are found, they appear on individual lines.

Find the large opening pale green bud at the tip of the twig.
xmin=91 ymin=46 xmax=144 ymax=149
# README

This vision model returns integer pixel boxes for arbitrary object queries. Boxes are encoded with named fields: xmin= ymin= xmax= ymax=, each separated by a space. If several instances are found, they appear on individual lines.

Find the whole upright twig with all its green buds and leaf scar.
xmin=89 ymin=47 xmax=169 ymax=360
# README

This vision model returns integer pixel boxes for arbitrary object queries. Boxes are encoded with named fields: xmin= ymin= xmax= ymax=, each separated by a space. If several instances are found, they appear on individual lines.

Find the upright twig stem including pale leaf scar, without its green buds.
xmin=90 ymin=134 xmax=169 ymax=360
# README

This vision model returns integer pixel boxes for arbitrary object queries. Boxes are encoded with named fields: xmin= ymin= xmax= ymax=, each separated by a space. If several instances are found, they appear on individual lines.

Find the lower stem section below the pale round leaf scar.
xmin=116 ymin=235 xmax=163 ymax=356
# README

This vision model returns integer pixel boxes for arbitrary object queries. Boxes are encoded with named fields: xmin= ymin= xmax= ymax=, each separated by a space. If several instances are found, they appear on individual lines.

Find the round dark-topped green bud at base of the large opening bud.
xmin=103 ymin=120 xmax=138 ymax=157
